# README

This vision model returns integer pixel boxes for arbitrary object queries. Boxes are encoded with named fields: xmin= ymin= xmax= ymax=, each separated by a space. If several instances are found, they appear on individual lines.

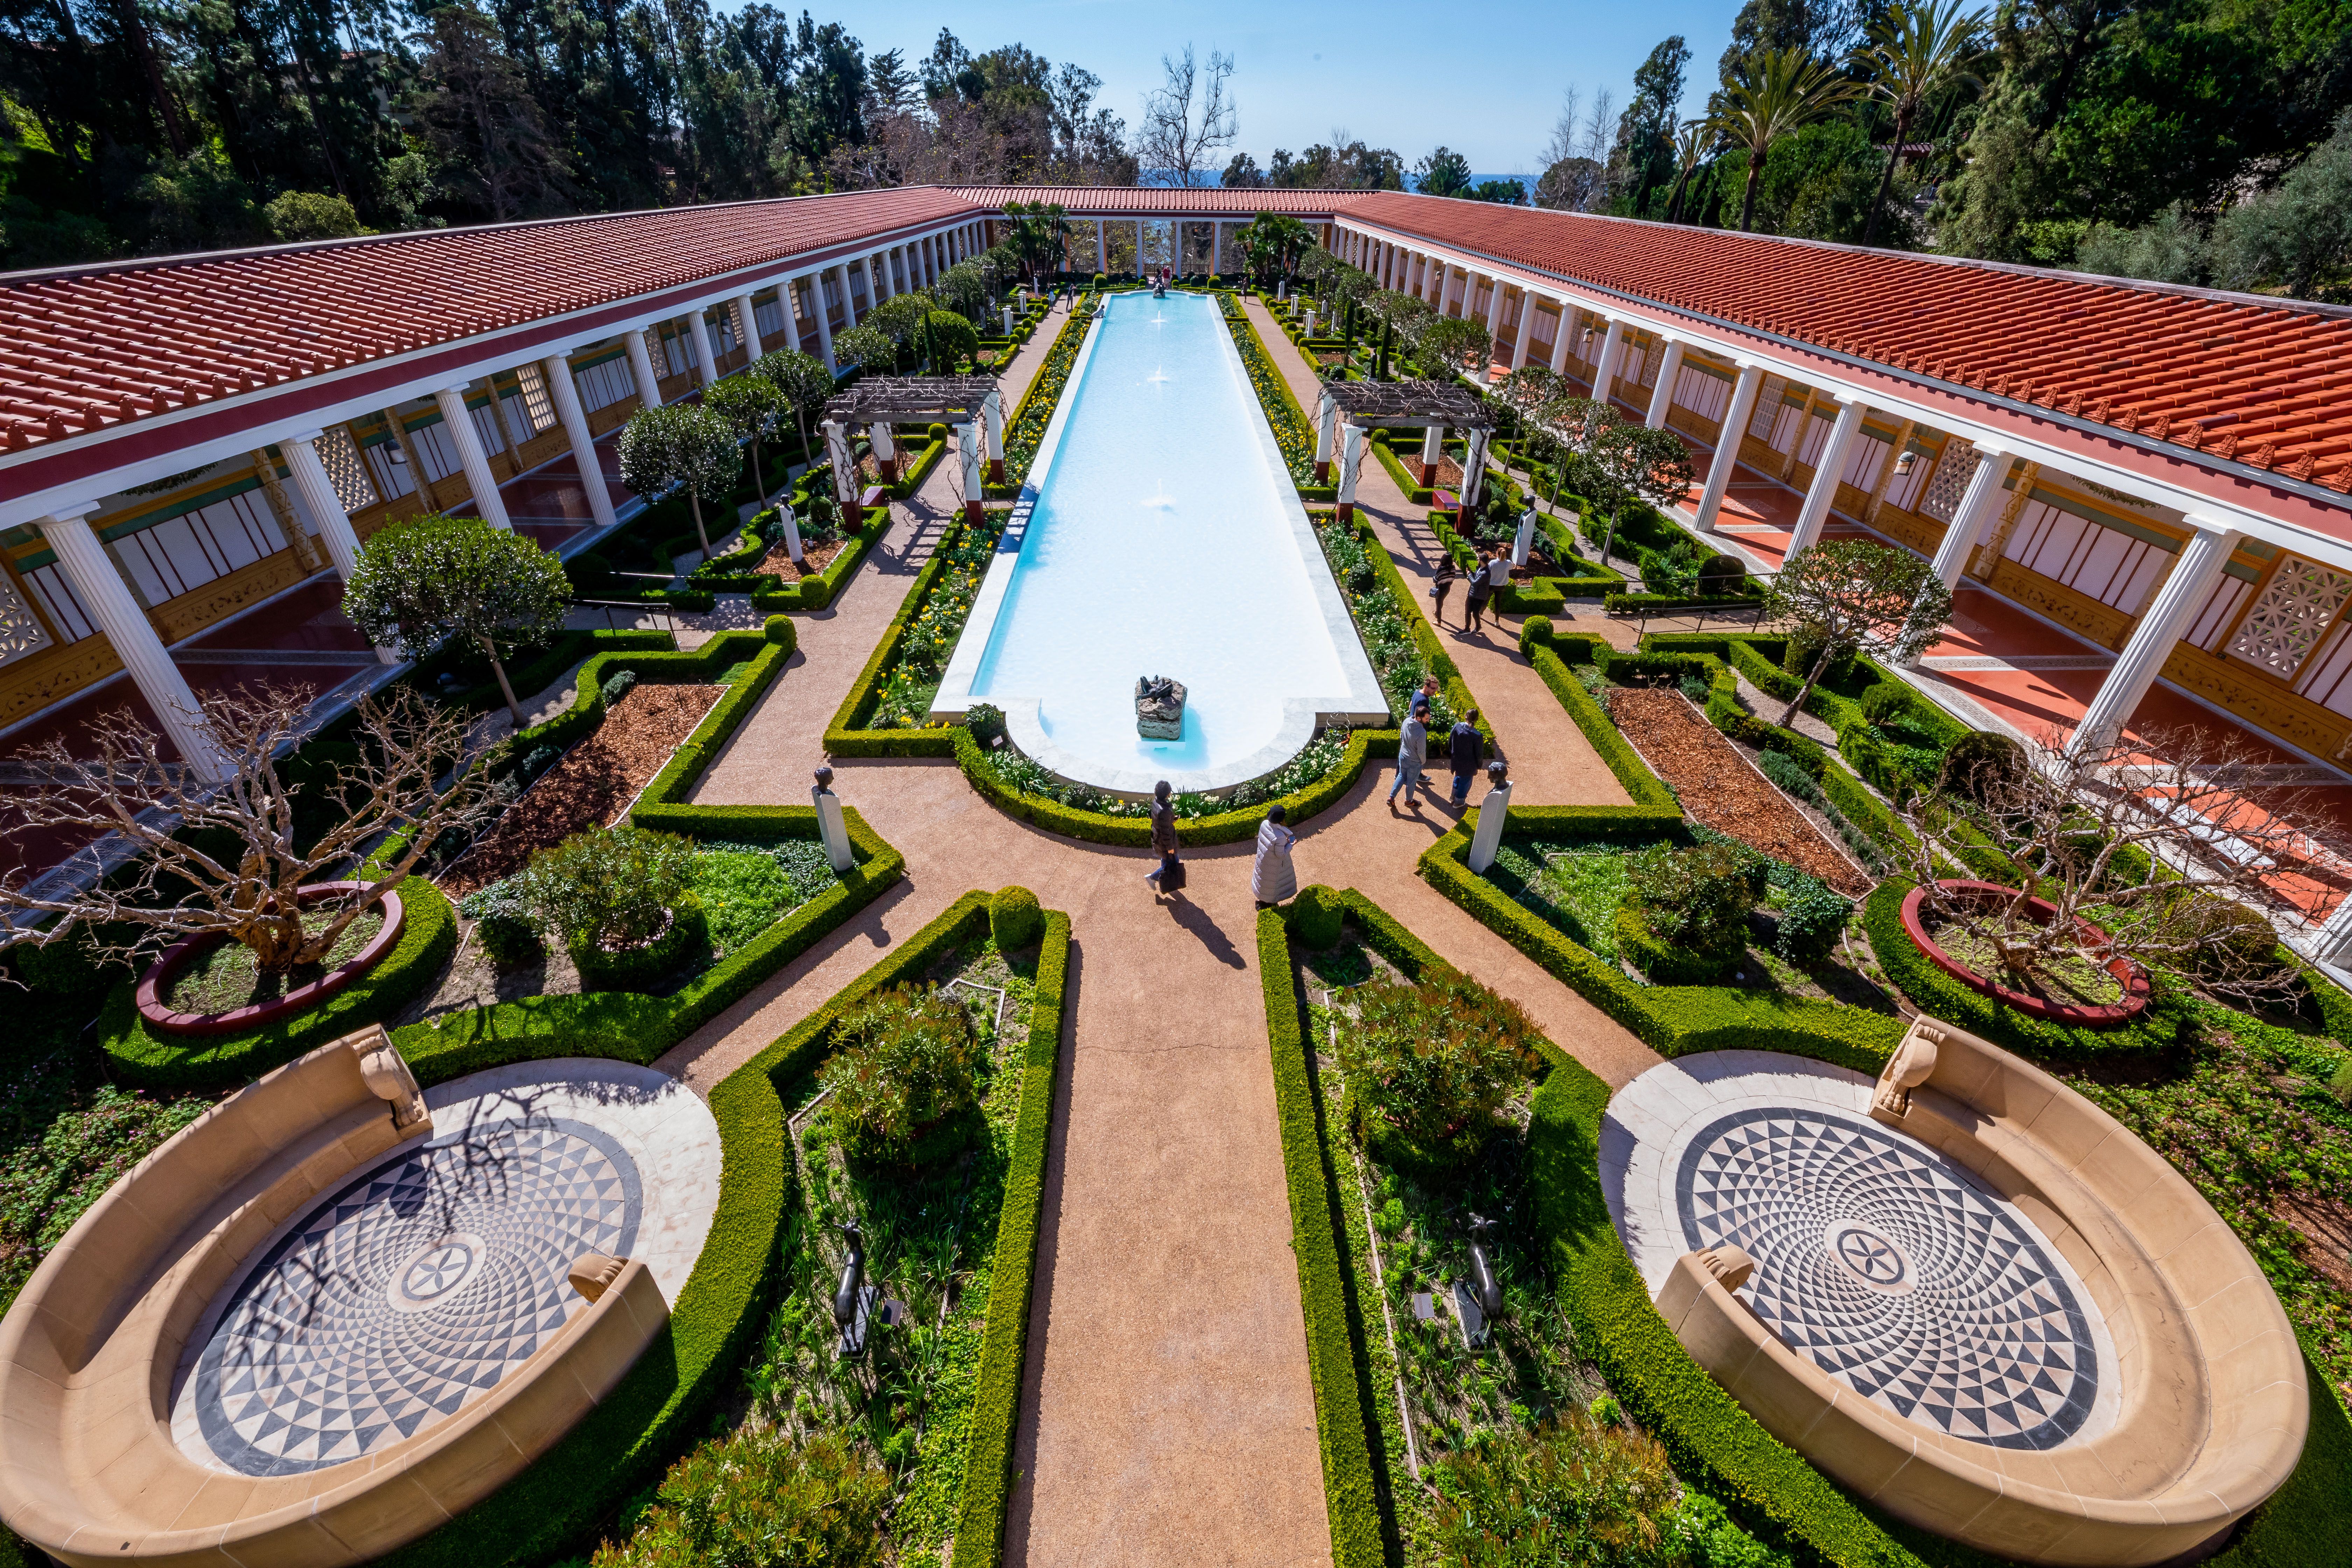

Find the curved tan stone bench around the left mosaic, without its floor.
xmin=0 ymin=1027 xmax=668 ymax=1568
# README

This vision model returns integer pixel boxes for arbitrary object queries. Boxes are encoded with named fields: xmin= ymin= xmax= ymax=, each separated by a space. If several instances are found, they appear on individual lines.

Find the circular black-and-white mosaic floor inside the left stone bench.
xmin=195 ymin=1116 xmax=642 ymax=1476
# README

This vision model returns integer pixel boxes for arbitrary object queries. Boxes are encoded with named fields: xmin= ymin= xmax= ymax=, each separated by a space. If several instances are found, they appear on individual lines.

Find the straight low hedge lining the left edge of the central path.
xmin=953 ymin=910 xmax=1070 ymax=1568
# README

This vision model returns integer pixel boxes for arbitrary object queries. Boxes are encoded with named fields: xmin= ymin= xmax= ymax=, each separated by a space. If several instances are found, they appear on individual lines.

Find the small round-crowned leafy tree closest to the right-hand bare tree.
xmin=1764 ymin=538 xmax=1952 ymax=729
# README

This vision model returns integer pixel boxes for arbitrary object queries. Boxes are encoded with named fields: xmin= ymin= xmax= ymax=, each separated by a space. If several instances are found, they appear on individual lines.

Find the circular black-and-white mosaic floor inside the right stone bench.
xmin=1675 ymin=1107 xmax=2098 ymax=1448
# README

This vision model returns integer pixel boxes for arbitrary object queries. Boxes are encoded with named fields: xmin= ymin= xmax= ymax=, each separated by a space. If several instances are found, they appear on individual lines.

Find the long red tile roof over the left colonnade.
xmin=0 ymin=188 xmax=979 ymax=449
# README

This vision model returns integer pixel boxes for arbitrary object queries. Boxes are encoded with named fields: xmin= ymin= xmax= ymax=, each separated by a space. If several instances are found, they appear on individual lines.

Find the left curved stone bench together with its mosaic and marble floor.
xmin=0 ymin=1027 xmax=718 ymax=1568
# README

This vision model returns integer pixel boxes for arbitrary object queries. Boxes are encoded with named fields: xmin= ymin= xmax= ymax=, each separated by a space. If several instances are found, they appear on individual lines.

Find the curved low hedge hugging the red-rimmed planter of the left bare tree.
xmin=99 ymin=877 xmax=456 ymax=1088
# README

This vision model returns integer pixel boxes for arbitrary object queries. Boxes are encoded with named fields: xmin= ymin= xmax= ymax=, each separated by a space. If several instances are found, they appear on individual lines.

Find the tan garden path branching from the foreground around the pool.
xmin=659 ymin=294 xmax=1656 ymax=1563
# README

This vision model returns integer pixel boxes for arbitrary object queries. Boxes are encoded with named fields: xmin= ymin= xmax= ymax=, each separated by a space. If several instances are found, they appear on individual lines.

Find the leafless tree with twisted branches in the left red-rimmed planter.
xmin=0 ymin=691 xmax=501 ymax=975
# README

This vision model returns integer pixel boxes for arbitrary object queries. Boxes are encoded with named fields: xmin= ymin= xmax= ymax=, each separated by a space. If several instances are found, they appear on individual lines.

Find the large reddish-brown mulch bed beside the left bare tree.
xmin=440 ymin=682 xmax=724 ymax=898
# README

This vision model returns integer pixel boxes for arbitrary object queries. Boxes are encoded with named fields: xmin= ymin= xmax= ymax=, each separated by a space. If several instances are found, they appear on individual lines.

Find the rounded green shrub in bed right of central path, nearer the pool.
xmin=1338 ymin=964 xmax=1543 ymax=1171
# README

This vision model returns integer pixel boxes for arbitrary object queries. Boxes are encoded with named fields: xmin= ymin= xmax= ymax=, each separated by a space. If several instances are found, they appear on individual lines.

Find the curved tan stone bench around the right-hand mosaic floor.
xmin=1658 ymin=1018 xmax=2310 ymax=1566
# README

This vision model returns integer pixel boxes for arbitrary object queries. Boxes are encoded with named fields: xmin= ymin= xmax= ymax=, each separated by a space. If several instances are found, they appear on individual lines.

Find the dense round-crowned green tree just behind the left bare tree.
xmin=343 ymin=514 xmax=571 ymax=729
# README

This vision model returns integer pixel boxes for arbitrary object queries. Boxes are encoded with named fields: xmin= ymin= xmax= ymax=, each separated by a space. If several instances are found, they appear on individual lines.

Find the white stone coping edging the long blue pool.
xmin=931 ymin=289 xmax=1395 ymax=799
